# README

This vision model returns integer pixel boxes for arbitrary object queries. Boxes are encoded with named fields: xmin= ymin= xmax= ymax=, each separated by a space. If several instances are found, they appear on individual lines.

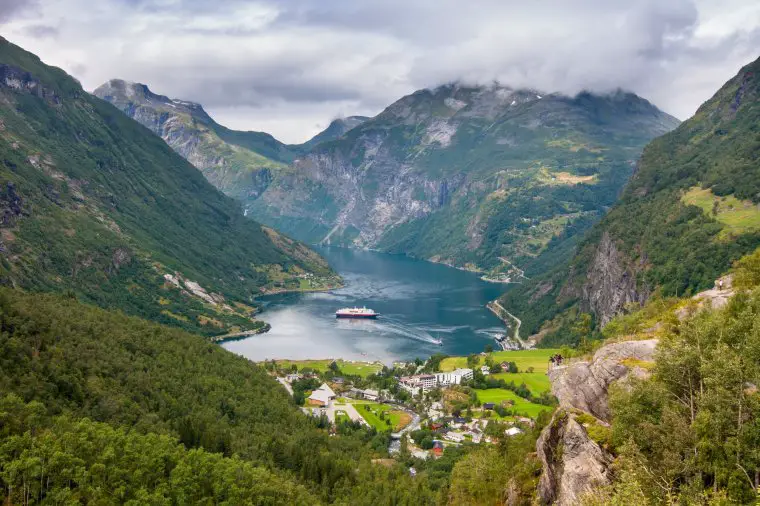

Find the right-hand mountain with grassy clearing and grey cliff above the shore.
xmin=502 ymin=55 xmax=760 ymax=344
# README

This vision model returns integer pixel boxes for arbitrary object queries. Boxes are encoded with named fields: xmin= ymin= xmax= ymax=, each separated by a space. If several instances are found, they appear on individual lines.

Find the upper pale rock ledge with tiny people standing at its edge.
xmin=549 ymin=339 xmax=657 ymax=422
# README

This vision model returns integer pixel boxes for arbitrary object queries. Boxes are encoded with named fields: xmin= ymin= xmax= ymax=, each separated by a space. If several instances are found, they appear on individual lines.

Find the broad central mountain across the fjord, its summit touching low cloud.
xmin=246 ymin=85 xmax=678 ymax=271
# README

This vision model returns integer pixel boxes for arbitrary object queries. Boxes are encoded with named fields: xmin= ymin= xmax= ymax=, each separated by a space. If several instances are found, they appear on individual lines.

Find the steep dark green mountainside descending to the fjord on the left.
xmin=0 ymin=39 xmax=337 ymax=334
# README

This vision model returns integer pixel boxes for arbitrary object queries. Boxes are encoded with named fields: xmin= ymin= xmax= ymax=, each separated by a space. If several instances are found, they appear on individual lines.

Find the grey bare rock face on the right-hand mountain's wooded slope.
xmin=583 ymin=232 xmax=649 ymax=326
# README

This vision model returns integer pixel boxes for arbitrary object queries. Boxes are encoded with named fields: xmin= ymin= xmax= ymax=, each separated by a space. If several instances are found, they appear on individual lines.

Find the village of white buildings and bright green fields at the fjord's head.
xmin=263 ymin=350 xmax=558 ymax=459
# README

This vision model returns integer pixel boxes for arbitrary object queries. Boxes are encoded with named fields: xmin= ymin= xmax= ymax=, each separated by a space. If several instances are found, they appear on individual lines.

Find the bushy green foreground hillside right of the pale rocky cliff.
xmin=582 ymin=250 xmax=760 ymax=506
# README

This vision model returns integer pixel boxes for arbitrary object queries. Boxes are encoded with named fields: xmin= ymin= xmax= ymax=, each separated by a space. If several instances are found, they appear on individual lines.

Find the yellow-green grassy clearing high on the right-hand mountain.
xmin=681 ymin=186 xmax=760 ymax=239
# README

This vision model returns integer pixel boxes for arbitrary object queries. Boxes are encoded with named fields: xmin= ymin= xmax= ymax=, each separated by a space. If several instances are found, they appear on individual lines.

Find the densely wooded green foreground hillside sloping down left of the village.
xmin=0 ymin=288 xmax=446 ymax=505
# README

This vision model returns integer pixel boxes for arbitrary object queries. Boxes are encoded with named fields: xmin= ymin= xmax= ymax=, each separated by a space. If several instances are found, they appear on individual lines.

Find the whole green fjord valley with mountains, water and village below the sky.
xmin=0 ymin=19 xmax=760 ymax=506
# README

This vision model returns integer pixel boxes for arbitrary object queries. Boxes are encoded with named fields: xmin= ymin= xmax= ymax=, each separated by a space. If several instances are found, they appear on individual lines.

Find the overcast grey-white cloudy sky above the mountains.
xmin=0 ymin=0 xmax=760 ymax=142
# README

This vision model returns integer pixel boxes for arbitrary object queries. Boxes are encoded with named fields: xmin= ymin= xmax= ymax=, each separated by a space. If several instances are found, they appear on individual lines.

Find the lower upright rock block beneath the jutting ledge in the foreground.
xmin=536 ymin=410 xmax=612 ymax=506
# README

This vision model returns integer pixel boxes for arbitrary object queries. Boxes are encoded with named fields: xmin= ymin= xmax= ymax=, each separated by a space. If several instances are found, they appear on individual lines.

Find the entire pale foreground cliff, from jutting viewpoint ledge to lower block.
xmin=536 ymin=339 xmax=657 ymax=506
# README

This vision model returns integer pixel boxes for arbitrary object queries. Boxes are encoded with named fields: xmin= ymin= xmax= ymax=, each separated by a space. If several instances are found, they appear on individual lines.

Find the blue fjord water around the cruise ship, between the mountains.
xmin=224 ymin=248 xmax=505 ymax=363
